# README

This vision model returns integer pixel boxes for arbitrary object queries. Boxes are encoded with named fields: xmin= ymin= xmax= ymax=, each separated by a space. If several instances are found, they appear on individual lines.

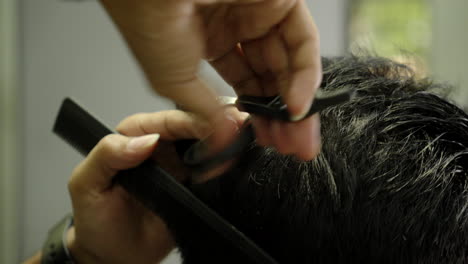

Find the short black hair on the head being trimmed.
xmin=168 ymin=56 xmax=468 ymax=263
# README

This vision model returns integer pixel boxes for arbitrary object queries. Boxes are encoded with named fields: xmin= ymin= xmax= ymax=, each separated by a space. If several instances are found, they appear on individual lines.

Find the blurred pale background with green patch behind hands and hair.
xmin=0 ymin=0 xmax=468 ymax=264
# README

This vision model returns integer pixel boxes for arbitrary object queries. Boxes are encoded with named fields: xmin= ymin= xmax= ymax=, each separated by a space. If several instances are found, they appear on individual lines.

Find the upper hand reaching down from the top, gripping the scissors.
xmin=101 ymin=0 xmax=321 ymax=159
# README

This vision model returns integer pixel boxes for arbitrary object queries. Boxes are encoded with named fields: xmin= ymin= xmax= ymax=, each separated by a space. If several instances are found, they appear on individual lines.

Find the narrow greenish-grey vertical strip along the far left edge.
xmin=0 ymin=0 xmax=20 ymax=263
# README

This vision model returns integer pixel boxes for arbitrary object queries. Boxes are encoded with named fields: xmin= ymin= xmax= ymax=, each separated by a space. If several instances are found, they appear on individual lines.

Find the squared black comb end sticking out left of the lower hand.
xmin=53 ymin=98 xmax=113 ymax=156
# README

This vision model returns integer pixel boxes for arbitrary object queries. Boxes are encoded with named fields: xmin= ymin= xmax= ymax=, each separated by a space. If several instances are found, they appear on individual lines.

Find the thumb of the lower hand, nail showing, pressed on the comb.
xmin=69 ymin=134 xmax=159 ymax=196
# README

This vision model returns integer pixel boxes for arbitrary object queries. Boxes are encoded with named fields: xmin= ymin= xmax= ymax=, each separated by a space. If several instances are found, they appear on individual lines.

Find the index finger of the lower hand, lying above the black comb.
xmin=116 ymin=110 xmax=212 ymax=141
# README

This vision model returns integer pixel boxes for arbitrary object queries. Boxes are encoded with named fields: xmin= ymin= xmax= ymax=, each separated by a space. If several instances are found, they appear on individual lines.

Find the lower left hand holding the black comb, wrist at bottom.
xmin=68 ymin=111 xmax=217 ymax=264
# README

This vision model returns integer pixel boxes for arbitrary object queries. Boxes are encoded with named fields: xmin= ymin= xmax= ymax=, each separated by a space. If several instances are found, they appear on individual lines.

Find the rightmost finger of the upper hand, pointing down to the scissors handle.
xmin=279 ymin=1 xmax=322 ymax=119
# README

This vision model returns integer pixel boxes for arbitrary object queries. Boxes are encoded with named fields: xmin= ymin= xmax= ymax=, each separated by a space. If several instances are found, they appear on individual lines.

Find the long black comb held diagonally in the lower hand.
xmin=53 ymin=98 xmax=277 ymax=264
